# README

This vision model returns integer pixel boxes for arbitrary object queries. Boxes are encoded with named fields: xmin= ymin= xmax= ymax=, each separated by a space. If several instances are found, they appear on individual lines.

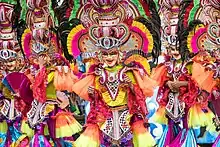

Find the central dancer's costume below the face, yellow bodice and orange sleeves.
xmin=57 ymin=52 xmax=156 ymax=146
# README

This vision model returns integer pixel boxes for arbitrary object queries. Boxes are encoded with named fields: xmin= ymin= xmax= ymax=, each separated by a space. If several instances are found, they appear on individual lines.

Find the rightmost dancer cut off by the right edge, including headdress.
xmin=187 ymin=0 xmax=220 ymax=146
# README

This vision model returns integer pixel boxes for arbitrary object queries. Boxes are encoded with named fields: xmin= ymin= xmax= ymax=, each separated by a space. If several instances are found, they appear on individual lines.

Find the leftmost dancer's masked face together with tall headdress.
xmin=0 ymin=3 xmax=24 ymax=71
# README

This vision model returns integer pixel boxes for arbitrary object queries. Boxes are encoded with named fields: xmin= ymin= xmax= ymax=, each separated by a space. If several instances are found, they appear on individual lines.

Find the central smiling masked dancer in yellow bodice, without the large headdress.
xmin=57 ymin=37 xmax=155 ymax=147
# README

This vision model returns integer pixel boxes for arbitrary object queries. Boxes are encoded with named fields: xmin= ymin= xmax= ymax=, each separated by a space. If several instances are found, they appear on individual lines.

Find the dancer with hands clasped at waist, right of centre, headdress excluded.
xmin=152 ymin=42 xmax=217 ymax=146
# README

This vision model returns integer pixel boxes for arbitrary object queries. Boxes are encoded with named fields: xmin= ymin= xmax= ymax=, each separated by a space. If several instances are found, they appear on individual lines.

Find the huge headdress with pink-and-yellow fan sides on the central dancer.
xmin=67 ymin=1 xmax=160 ymax=63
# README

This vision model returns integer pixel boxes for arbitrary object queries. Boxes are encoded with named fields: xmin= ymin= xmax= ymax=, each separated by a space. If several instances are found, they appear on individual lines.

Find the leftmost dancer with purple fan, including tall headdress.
xmin=0 ymin=1 xmax=33 ymax=147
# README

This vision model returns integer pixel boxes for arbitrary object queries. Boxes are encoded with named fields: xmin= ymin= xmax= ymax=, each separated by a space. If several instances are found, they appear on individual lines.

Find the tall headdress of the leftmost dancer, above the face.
xmin=0 ymin=0 xmax=23 ymax=67
